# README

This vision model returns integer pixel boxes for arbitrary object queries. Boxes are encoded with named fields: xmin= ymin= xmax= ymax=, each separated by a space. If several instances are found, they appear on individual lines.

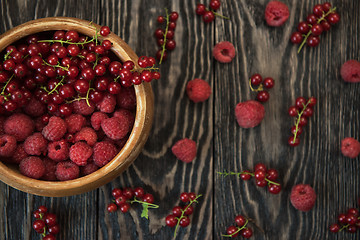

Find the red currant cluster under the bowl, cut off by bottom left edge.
xmin=33 ymin=206 xmax=60 ymax=240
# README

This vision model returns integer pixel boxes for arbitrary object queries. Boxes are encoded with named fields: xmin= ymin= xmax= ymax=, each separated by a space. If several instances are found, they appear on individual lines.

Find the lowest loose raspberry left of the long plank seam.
xmin=171 ymin=138 xmax=196 ymax=163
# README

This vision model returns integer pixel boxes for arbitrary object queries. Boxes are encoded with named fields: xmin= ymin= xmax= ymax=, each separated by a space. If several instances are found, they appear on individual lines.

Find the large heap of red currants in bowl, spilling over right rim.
xmin=0 ymin=26 xmax=160 ymax=114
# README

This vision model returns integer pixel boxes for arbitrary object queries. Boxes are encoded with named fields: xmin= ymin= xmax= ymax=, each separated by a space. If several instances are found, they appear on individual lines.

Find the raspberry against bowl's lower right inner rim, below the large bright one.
xmin=94 ymin=141 xmax=118 ymax=167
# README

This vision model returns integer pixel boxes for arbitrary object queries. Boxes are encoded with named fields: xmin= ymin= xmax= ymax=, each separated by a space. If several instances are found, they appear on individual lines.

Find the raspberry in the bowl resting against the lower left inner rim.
xmin=19 ymin=156 xmax=45 ymax=179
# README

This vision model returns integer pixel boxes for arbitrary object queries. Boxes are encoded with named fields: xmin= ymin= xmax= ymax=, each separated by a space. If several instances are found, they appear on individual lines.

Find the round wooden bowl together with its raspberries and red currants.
xmin=0 ymin=17 xmax=156 ymax=197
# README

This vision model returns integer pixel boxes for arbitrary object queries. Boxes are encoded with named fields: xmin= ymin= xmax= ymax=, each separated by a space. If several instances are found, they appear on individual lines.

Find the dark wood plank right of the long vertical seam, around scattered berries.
xmin=214 ymin=0 xmax=360 ymax=239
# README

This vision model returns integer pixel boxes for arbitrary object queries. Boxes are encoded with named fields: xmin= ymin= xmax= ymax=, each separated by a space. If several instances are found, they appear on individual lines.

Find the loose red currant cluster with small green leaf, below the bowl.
xmin=107 ymin=187 xmax=159 ymax=219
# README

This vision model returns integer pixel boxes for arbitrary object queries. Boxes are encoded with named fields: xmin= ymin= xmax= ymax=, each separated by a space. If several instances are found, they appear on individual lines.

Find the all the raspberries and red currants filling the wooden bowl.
xmin=0 ymin=26 xmax=150 ymax=181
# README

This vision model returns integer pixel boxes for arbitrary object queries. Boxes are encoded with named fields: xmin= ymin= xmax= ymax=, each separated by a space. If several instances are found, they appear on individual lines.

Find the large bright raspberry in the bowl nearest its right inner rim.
xmin=101 ymin=116 xmax=130 ymax=140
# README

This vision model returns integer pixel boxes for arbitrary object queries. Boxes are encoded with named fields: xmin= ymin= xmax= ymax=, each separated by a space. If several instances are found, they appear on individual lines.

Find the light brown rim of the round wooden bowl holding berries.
xmin=0 ymin=17 xmax=154 ymax=197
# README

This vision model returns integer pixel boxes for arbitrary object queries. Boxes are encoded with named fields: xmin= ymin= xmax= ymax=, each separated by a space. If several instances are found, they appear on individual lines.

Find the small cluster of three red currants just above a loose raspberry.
xmin=249 ymin=73 xmax=274 ymax=102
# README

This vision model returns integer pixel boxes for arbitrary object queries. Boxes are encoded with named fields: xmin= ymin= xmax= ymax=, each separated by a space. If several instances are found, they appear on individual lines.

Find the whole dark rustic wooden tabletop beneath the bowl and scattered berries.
xmin=0 ymin=0 xmax=360 ymax=240
